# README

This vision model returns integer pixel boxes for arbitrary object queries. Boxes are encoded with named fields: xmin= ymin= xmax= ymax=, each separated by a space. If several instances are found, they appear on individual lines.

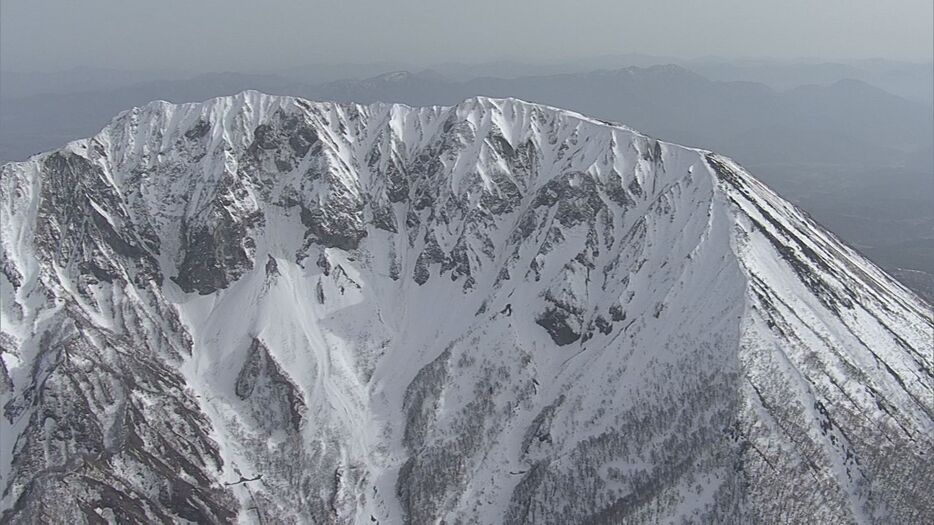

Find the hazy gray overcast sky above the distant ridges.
xmin=0 ymin=0 xmax=934 ymax=70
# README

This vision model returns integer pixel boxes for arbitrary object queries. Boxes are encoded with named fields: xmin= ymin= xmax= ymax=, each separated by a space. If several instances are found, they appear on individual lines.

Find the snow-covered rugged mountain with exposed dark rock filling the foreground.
xmin=0 ymin=92 xmax=934 ymax=523
